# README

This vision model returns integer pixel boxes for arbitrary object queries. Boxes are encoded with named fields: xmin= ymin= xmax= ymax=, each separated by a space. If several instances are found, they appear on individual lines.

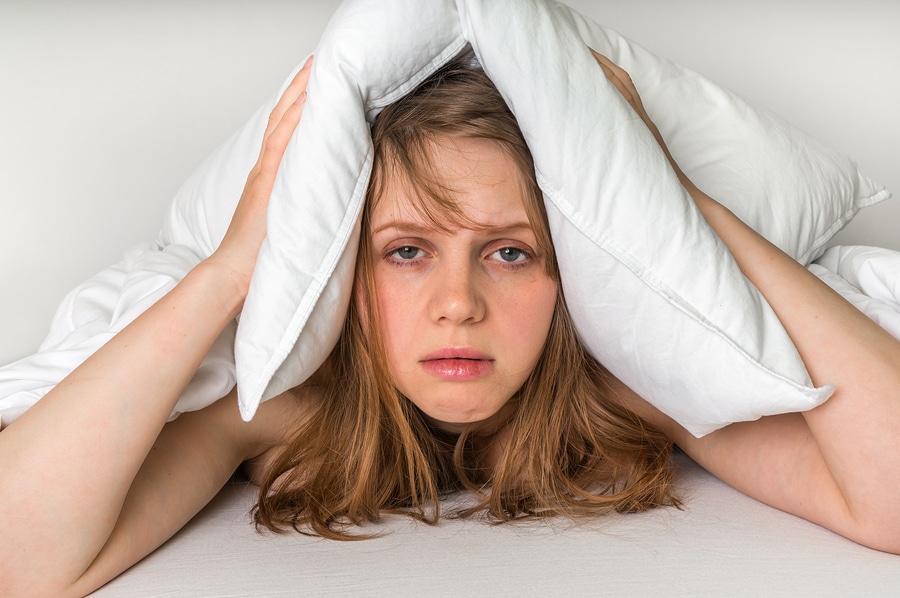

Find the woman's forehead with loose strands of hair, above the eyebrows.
xmin=371 ymin=136 xmax=528 ymax=229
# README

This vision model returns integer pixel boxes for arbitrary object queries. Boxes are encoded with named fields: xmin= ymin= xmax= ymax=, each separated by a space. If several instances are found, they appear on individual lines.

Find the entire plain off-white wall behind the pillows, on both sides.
xmin=0 ymin=0 xmax=900 ymax=364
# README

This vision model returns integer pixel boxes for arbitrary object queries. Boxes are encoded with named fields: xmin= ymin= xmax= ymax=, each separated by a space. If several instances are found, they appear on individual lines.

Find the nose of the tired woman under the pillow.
xmin=431 ymin=260 xmax=487 ymax=324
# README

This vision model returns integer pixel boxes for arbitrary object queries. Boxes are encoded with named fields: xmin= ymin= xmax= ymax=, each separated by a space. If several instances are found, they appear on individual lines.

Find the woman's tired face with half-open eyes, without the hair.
xmin=369 ymin=137 xmax=557 ymax=430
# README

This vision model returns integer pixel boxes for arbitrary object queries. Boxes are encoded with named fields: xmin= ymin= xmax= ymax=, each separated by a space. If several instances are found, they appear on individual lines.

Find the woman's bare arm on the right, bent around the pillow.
xmin=597 ymin=56 xmax=900 ymax=553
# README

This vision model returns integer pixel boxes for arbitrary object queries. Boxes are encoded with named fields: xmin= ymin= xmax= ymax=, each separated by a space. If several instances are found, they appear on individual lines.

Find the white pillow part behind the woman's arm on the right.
xmin=584 ymin=17 xmax=891 ymax=265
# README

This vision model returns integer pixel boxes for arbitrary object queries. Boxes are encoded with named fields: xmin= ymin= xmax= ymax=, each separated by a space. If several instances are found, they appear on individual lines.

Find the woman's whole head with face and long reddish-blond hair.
xmin=256 ymin=57 xmax=672 ymax=539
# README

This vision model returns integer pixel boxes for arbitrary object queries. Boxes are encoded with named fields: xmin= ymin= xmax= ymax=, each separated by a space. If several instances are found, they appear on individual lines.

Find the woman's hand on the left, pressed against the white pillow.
xmin=206 ymin=56 xmax=313 ymax=295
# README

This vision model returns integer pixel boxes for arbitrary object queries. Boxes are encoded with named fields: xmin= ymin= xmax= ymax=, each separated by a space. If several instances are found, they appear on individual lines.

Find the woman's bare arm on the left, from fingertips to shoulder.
xmin=0 ymin=57 xmax=310 ymax=596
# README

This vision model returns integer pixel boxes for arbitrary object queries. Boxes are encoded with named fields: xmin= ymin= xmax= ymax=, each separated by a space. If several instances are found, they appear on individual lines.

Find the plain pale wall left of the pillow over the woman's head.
xmin=0 ymin=0 xmax=337 ymax=363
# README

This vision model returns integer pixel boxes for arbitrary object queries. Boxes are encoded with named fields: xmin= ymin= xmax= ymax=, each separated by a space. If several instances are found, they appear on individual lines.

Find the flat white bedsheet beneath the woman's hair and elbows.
xmin=94 ymin=455 xmax=900 ymax=598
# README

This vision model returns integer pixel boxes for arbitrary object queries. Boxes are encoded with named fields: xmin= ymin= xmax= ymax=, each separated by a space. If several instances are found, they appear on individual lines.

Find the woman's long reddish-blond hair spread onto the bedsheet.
xmin=254 ymin=54 xmax=677 ymax=539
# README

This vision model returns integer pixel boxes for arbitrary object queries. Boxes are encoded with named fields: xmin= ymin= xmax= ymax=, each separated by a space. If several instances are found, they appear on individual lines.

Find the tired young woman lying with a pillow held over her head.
xmin=0 ymin=49 xmax=900 ymax=596
